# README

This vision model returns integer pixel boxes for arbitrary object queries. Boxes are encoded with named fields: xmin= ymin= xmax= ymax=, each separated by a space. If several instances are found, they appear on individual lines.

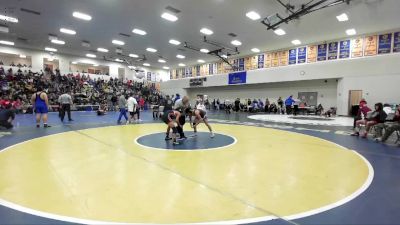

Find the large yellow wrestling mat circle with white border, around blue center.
xmin=0 ymin=124 xmax=373 ymax=224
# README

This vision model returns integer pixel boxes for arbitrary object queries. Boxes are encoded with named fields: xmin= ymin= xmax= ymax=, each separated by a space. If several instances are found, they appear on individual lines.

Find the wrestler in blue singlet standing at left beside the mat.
xmin=31 ymin=86 xmax=51 ymax=128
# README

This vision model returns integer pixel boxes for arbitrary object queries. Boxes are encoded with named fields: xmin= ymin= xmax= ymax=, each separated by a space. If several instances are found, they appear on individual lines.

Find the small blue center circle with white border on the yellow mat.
xmin=136 ymin=132 xmax=236 ymax=151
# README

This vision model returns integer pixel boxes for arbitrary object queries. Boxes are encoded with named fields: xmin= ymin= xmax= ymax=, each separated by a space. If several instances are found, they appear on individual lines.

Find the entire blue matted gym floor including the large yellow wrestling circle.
xmin=0 ymin=112 xmax=400 ymax=224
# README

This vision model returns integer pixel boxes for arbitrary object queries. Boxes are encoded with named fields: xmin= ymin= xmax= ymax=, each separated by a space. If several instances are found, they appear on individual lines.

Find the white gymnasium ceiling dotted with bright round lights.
xmin=0 ymin=0 xmax=400 ymax=68
